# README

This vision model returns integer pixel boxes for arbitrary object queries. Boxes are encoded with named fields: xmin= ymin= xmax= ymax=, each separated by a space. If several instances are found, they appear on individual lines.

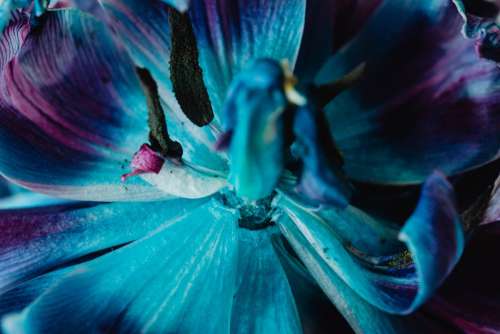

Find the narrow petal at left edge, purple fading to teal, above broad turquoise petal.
xmin=0 ymin=200 xmax=203 ymax=291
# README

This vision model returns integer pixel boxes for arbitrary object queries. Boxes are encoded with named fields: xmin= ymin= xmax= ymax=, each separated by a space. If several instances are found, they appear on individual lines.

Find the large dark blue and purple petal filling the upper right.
xmin=318 ymin=0 xmax=500 ymax=184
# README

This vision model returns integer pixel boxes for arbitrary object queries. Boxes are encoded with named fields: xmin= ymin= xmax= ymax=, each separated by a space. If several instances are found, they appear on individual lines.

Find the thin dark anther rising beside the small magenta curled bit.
xmin=136 ymin=67 xmax=182 ymax=158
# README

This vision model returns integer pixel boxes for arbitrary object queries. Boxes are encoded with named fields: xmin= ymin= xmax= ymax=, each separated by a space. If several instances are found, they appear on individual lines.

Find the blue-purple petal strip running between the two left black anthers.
xmin=95 ymin=0 xmax=227 ymax=171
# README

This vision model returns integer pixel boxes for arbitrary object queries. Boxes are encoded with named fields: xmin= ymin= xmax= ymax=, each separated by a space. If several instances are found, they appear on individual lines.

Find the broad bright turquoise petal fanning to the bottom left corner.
xmin=3 ymin=201 xmax=237 ymax=333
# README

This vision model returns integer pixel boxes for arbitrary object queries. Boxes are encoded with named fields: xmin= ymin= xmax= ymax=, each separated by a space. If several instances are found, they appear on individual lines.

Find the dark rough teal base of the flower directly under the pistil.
xmin=217 ymin=190 xmax=276 ymax=230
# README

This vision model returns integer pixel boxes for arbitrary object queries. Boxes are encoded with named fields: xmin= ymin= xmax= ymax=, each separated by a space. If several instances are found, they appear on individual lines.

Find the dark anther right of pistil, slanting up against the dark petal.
xmin=313 ymin=63 xmax=366 ymax=108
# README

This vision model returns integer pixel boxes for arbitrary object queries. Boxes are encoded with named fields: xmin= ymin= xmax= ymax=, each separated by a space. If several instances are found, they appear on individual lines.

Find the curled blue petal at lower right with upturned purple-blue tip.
xmin=281 ymin=173 xmax=464 ymax=314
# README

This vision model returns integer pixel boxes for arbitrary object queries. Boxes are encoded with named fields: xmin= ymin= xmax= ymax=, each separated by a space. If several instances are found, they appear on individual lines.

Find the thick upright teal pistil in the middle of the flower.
xmin=224 ymin=59 xmax=290 ymax=200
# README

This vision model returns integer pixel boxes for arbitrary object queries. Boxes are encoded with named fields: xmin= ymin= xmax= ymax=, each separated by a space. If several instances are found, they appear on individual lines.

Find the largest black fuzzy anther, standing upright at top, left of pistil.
xmin=168 ymin=8 xmax=214 ymax=126
